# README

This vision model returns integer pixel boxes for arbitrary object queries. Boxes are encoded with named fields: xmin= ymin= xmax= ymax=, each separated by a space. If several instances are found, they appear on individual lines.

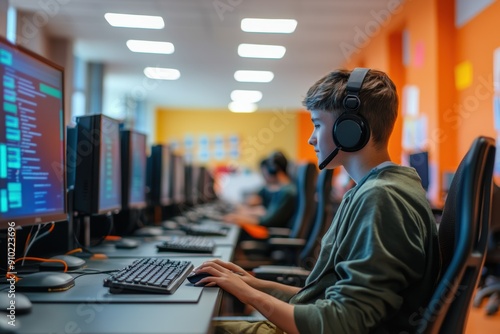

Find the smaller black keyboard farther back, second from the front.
xmin=156 ymin=235 xmax=215 ymax=254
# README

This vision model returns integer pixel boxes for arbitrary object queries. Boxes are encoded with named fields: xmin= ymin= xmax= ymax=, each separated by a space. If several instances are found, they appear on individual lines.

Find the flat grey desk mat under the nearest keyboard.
xmin=24 ymin=259 xmax=203 ymax=303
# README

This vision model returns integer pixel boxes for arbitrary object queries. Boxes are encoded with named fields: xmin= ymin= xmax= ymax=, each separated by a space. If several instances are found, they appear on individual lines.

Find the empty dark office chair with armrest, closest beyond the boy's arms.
xmin=253 ymin=170 xmax=334 ymax=286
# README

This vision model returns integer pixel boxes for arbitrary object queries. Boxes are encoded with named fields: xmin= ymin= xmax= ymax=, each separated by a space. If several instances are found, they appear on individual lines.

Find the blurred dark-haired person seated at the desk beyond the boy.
xmin=224 ymin=151 xmax=297 ymax=227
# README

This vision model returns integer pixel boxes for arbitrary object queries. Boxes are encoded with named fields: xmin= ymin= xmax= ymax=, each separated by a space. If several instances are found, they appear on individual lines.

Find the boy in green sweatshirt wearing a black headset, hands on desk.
xmin=190 ymin=69 xmax=440 ymax=334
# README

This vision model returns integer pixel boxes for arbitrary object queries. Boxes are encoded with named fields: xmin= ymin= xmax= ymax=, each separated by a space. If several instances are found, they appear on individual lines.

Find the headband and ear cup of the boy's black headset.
xmin=333 ymin=67 xmax=370 ymax=152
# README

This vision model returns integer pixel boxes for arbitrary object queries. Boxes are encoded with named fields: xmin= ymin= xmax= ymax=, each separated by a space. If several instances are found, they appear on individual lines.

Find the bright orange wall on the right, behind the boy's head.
xmin=340 ymin=0 xmax=500 ymax=204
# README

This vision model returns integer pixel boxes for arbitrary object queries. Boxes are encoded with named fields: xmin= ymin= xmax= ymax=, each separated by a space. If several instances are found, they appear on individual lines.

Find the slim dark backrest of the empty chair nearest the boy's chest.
xmin=299 ymin=169 xmax=333 ymax=270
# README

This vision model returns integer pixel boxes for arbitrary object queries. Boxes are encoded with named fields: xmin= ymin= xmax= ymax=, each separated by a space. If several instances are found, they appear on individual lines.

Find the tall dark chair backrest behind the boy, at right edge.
xmin=417 ymin=137 xmax=495 ymax=333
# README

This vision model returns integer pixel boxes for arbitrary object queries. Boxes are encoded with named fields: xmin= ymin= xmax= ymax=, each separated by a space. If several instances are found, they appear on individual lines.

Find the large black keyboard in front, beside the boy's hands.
xmin=104 ymin=258 xmax=194 ymax=294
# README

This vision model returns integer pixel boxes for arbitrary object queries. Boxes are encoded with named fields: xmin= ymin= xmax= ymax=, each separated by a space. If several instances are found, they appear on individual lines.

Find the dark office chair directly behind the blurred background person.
xmin=235 ymin=163 xmax=318 ymax=269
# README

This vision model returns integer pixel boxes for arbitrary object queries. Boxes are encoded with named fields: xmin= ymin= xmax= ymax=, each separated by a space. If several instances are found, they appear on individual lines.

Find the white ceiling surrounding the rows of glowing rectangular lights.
xmin=6 ymin=0 xmax=393 ymax=109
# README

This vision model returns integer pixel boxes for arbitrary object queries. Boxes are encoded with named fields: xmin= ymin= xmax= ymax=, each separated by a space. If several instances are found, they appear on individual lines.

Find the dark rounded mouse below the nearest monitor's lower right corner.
xmin=16 ymin=271 xmax=75 ymax=292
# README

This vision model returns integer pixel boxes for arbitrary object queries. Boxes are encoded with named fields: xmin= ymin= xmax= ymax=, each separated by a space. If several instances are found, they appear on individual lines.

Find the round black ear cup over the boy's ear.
xmin=333 ymin=112 xmax=370 ymax=152
